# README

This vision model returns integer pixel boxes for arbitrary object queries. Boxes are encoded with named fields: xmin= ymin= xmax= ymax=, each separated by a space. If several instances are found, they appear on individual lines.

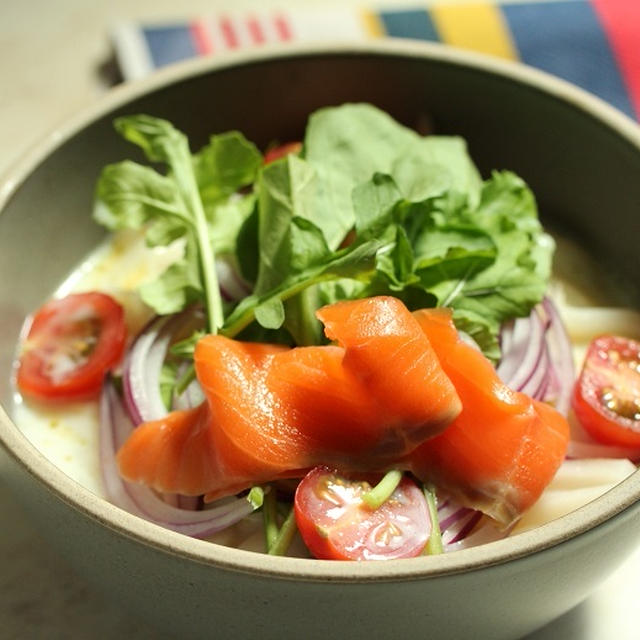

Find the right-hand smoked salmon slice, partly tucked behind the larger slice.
xmin=408 ymin=309 xmax=569 ymax=526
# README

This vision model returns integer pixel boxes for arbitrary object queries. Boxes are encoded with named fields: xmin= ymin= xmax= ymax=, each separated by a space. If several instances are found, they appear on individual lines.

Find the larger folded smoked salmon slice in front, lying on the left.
xmin=118 ymin=297 xmax=461 ymax=499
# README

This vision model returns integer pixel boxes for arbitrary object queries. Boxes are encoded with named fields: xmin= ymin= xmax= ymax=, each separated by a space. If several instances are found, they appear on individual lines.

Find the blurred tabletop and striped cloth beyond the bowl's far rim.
xmin=0 ymin=0 xmax=640 ymax=178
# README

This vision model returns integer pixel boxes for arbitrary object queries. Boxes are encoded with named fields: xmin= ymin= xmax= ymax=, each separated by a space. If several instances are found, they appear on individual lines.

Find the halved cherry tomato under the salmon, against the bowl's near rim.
xmin=295 ymin=467 xmax=431 ymax=560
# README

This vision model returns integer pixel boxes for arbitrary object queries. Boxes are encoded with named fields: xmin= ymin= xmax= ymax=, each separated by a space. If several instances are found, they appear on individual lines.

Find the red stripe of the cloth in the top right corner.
xmin=591 ymin=0 xmax=640 ymax=119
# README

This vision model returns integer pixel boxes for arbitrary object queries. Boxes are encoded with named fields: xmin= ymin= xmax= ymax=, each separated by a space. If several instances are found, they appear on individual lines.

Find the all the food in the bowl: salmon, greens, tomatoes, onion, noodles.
xmin=14 ymin=103 xmax=640 ymax=560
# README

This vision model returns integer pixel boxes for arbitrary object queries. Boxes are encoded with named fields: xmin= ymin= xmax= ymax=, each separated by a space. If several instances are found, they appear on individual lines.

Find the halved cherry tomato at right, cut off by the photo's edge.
xmin=572 ymin=336 xmax=640 ymax=446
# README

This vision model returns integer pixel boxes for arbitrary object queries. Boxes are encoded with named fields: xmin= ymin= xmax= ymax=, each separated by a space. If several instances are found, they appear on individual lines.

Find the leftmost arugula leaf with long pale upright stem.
xmin=94 ymin=115 xmax=261 ymax=332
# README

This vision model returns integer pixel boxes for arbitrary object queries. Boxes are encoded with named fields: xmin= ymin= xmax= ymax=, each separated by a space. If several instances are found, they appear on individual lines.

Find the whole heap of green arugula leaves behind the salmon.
xmin=95 ymin=104 xmax=553 ymax=360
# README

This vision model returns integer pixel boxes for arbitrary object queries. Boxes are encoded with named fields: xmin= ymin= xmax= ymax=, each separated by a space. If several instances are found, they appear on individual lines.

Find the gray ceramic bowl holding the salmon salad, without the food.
xmin=0 ymin=43 xmax=640 ymax=639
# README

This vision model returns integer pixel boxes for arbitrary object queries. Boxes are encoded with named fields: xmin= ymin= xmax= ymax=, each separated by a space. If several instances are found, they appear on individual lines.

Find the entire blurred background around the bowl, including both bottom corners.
xmin=0 ymin=0 xmax=640 ymax=640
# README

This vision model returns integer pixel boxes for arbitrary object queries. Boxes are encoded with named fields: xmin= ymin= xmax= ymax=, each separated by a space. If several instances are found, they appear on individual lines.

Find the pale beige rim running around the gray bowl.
xmin=0 ymin=39 xmax=640 ymax=583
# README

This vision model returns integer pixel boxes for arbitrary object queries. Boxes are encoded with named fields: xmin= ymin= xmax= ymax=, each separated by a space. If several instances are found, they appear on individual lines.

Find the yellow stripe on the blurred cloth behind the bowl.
xmin=429 ymin=2 xmax=518 ymax=60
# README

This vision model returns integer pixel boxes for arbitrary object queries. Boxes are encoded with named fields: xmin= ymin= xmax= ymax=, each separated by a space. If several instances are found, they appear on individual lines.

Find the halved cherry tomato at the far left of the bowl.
xmin=16 ymin=292 xmax=126 ymax=401
